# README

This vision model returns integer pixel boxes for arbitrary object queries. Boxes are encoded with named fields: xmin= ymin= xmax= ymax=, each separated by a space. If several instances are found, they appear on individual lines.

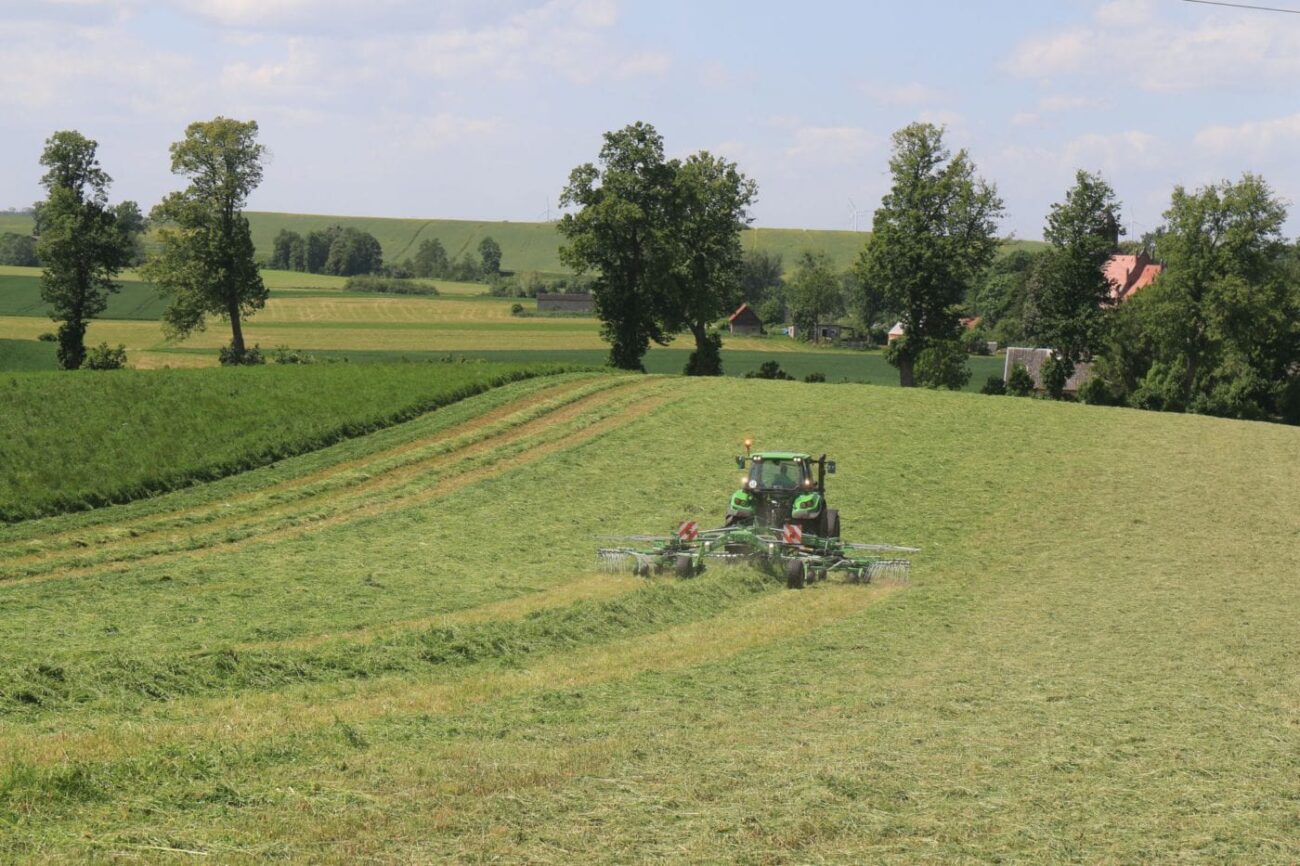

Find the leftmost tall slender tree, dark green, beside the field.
xmin=36 ymin=130 xmax=138 ymax=369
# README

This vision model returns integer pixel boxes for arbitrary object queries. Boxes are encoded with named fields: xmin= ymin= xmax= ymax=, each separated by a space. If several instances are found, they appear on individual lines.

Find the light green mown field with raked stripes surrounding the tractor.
xmin=0 ymin=368 xmax=1300 ymax=863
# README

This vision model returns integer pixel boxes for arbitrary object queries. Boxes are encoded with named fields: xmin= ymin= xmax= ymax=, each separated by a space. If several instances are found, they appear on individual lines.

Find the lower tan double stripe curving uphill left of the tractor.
xmin=0 ymin=380 xmax=667 ymax=588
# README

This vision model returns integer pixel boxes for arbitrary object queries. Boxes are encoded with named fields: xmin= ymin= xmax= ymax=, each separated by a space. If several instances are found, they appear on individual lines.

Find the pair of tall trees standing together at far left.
xmin=35 ymin=117 xmax=268 ymax=369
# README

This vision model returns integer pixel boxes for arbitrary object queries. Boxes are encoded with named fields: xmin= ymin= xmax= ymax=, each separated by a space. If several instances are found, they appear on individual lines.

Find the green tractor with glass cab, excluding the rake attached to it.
xmin=727 ymin=441 xmax=840 ymax=538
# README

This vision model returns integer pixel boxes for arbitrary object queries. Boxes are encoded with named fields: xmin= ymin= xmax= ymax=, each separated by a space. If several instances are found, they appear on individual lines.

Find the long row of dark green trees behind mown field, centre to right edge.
xmin=559 ymin=124 xmax=1300 ymax=423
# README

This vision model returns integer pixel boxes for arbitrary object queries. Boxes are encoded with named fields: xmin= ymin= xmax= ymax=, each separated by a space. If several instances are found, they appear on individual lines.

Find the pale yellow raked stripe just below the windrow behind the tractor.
xmin=0 ymin=584 xmax=894 ymax=774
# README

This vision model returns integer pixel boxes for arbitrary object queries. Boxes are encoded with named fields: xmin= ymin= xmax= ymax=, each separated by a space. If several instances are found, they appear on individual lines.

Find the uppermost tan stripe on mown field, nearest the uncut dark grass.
xmin=0 ymin=376 xmax=629 ymax=556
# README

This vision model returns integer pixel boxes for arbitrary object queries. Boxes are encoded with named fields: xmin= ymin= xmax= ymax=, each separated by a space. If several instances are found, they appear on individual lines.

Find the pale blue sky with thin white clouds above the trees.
xmin=0 ymin=0 xmax=1300 ymax=238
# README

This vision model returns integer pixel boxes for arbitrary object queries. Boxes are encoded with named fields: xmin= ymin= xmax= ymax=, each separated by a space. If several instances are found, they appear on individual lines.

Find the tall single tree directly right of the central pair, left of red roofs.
xmin=857 ymin=124 xmax=1002 ymax=387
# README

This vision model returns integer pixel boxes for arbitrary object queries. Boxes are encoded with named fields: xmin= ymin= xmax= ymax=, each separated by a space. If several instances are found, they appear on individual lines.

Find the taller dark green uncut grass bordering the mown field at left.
xmin=0 ymin=363 xmax=579 ymax=520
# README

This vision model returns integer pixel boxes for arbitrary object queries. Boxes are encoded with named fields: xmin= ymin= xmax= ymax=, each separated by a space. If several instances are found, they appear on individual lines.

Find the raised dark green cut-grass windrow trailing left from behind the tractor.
xmin=0 ymin=570 xmax=780 ymax=718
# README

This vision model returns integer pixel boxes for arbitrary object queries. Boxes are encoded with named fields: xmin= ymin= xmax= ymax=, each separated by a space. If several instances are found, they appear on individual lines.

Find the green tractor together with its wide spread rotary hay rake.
xmin=598 ymin=440 xmax=919 ymax=589
